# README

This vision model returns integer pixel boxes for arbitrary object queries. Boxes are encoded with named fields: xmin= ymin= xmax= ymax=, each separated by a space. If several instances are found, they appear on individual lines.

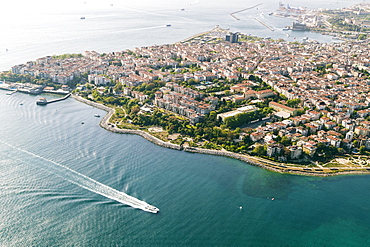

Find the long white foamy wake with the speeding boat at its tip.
xmin=0 ymin=140 xmax=159 ymax=213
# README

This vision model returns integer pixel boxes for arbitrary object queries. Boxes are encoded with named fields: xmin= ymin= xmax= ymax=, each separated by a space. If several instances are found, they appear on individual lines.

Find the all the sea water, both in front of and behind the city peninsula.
xmin=0 ymin=0 xmax=370 ymax=247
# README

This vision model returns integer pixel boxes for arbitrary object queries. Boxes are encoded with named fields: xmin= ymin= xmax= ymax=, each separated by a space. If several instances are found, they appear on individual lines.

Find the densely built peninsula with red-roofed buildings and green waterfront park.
xmin=0 ymin=27 xmax=370 ymax=176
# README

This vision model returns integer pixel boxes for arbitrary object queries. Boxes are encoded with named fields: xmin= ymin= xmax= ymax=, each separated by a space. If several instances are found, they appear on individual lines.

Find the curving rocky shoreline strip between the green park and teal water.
xmin=72 ymin=95 xmax=370 ymax=177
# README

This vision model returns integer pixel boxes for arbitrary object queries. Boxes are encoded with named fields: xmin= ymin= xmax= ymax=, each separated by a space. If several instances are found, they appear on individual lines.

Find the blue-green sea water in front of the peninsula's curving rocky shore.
xmin=0 ymin=91 xmax=370 ymax=246
